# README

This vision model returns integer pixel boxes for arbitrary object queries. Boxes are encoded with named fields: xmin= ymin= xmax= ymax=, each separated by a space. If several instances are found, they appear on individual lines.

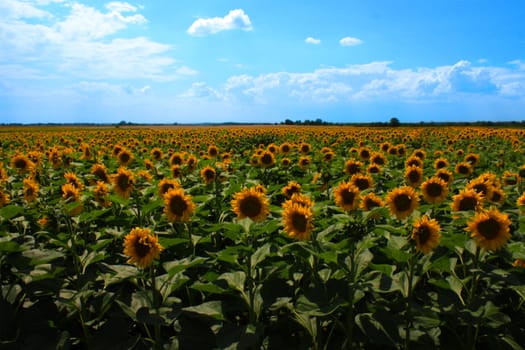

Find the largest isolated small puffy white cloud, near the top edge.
xmin=187 ymin=9 xmax=252 ymax=36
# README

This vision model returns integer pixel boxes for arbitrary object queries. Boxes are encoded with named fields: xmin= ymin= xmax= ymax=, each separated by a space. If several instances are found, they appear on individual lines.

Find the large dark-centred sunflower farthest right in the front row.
xmin=465 ymin=208 xmax=511 ymax=251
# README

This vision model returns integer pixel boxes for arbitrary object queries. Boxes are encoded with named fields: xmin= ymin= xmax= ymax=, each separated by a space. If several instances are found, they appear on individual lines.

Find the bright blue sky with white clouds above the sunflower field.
xmin=0 ymin=0 xmax=525 ymax=123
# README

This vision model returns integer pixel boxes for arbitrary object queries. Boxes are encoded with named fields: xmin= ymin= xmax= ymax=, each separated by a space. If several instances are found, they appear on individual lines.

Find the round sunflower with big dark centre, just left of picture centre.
xmin=231 ymin=188 xmax=270 ymax=222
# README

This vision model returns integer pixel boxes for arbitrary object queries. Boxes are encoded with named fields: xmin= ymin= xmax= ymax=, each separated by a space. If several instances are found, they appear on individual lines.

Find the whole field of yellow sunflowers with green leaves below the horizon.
xmin=0 ymin=126 xmax=525 ymax=349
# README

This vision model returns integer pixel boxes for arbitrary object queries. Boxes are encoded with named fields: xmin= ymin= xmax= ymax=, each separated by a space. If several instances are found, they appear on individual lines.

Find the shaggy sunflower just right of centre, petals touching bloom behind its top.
xmin=282 ymin=203 xmax=313 ymax=241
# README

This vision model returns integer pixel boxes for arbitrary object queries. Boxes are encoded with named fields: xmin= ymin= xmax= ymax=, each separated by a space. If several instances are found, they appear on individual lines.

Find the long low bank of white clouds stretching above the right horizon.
xmin=183 ymin=60 xmax=525 ymax=104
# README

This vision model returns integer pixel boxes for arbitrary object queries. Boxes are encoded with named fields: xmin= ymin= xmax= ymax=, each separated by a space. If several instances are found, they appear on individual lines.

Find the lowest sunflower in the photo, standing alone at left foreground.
xmin=124 ymin=227 xmax=163 ymax=268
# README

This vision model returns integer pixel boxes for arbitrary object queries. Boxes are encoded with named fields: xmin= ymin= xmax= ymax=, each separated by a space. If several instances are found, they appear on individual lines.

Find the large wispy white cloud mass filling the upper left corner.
xmin=0 ymin=0 xmax=177 ymax=80
